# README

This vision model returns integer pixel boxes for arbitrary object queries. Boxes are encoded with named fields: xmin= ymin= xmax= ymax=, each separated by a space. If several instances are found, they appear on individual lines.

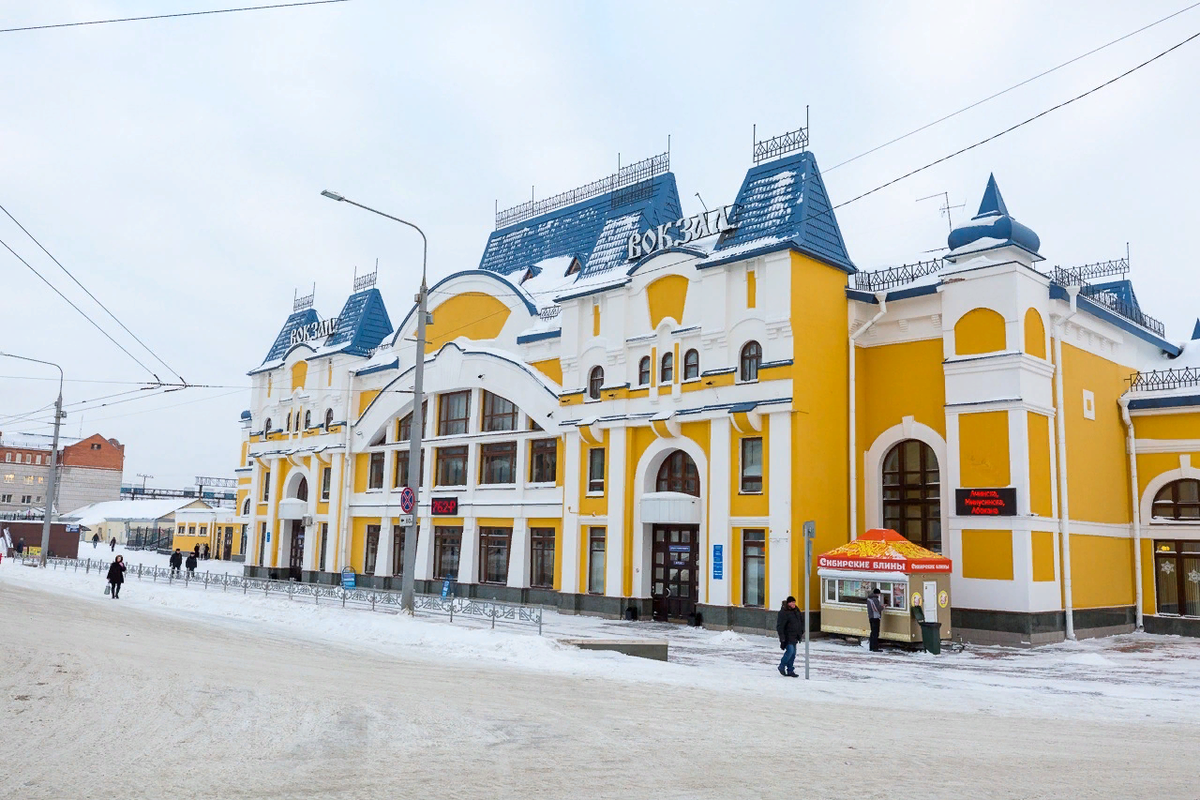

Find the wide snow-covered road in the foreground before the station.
xmin=0 ymin=570 xmax=1196 ymax=799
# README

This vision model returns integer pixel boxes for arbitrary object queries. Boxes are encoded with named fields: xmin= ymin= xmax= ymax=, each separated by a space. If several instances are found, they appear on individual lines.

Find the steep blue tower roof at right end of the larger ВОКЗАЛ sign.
xmin=710 ymin=152 xmax=858 ymax=272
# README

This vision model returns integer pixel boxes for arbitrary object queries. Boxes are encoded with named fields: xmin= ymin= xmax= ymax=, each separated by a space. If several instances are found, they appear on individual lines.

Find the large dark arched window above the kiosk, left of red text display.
xmin=883 ymin=439 xmax=942 ymax=553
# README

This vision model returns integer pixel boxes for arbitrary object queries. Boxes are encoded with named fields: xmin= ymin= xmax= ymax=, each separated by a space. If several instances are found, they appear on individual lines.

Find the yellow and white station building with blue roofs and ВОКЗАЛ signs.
xmin=238 ymin=143 xmax=1200 ymax=644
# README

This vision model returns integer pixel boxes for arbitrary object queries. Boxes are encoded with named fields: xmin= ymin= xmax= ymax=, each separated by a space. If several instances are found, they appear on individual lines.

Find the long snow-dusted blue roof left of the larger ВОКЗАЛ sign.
xmin=479 ymin=173 xmax=682 ymax=275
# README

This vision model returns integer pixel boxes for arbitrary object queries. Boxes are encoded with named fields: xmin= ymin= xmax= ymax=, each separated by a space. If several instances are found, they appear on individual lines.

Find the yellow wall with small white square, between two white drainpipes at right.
xmin=1062 ymin=342 xmax=1132 ymax=523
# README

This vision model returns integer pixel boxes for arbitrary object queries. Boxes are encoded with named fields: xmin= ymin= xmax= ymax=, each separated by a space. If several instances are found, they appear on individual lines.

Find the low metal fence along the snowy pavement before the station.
xmin=20 ymin=557 xmax=542 ymax=636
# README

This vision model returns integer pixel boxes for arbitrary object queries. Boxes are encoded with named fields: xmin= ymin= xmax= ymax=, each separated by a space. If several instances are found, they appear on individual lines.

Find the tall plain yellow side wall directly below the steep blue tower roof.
xmin=792 ymin=253 xmax=850 ymax=597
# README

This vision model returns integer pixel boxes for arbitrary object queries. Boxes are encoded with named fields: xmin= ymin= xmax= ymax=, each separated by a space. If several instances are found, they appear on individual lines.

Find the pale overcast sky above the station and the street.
xmin=0 ymin=0 xmax=1200 ymax=486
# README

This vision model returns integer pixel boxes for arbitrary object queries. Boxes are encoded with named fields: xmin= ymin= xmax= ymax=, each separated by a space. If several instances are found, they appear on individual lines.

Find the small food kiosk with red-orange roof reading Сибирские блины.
xmin=817 ymin=528 xmax=952 ymax=644
